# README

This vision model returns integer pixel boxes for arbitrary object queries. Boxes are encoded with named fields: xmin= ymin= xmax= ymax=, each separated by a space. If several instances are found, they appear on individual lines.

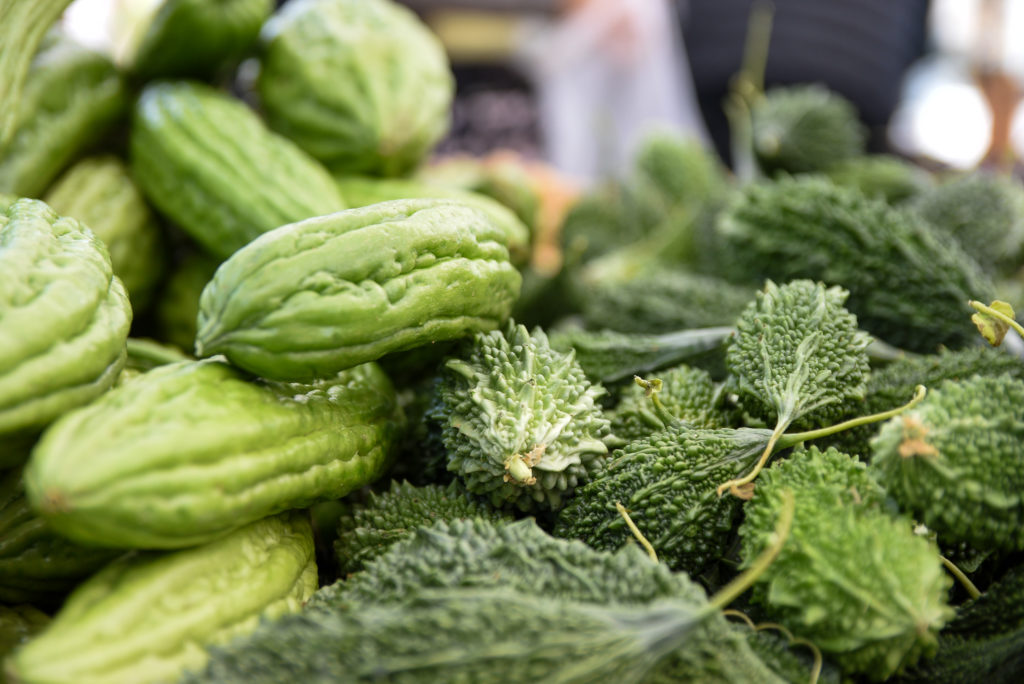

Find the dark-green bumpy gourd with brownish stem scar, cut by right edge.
xmin=871 ymin=376 xmax=1024 ymax=550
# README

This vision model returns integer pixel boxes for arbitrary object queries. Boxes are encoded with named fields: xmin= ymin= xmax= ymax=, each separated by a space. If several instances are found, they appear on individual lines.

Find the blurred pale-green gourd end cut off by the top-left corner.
xmin=0 ymin=0 xmax=71 ymax=151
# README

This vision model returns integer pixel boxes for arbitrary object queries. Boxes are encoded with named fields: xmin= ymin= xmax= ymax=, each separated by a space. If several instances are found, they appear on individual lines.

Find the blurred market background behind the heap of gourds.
xmin=66 ymin=0 xmax=1024 ymax=185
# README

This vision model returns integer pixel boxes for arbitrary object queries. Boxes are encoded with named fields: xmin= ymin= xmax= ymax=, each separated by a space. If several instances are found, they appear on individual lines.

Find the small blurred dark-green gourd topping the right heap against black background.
xmin=751 ymin=85 xmax=867 ymax=175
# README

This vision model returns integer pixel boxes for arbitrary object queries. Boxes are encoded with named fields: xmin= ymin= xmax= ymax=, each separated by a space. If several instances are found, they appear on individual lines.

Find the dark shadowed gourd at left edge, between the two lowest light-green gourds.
xmin=0 ymin=468 xmax=117 ymax=605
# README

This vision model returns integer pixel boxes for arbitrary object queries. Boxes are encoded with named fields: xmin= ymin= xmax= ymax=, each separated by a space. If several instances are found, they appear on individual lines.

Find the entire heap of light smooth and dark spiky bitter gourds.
xmin=0 ymin=0 xmax=1024 ymax=684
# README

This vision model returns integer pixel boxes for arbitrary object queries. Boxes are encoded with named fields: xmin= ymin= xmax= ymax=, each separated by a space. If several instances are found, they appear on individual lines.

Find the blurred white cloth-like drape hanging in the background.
xmin=520 ymin=0 xmax=710 ymax=184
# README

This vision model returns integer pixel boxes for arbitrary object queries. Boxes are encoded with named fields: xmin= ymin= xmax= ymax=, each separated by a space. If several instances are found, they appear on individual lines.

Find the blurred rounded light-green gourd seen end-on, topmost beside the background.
xmin=258 ymin=0 xmax=455 ymax=176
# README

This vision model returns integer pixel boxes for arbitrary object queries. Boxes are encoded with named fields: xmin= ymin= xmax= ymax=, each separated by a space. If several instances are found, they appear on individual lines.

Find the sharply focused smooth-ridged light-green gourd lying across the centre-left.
xmin=196 ymin=200 xmax=522 ymax=380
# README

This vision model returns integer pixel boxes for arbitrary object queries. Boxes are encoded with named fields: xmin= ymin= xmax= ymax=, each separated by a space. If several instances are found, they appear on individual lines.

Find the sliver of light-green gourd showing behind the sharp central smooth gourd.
xmin=337 ymin=176 xmax=529 ymax=264
